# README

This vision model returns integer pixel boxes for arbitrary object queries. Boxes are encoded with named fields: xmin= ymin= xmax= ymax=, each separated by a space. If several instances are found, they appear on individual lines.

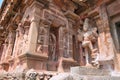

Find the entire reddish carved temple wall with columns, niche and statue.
xmin=1 ymin=0 xmax=119 ymax=77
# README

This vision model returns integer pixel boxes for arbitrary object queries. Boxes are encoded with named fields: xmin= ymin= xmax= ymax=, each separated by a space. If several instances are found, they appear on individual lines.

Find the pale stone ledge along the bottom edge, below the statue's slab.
xmin=50 ymin=73 xmax=120 ymax=80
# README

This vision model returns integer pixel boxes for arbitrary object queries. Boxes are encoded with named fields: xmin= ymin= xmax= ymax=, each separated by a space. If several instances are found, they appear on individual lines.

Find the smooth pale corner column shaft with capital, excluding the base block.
xmin=28 ymin=1 xmax=43 ymax=53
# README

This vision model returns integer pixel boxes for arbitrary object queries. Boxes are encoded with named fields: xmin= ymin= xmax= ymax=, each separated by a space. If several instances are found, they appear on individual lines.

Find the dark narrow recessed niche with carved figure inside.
xmin=49 ymin=27 xmax=59 ymax=61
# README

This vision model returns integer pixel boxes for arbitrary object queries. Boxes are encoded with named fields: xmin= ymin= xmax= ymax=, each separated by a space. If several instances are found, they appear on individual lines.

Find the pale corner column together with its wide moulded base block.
xmin=18 ymin=1 xmax=48 ymax=70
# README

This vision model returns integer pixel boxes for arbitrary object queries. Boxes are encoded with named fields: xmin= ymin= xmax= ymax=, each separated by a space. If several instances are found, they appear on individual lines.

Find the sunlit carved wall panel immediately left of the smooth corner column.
xmin=14 ymin=15 xmax=30 ymax=56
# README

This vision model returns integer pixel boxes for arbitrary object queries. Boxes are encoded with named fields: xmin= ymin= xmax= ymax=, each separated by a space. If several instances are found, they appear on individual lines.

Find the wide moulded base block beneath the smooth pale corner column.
xmin=19 ymin=53 xmax=48 ymax=70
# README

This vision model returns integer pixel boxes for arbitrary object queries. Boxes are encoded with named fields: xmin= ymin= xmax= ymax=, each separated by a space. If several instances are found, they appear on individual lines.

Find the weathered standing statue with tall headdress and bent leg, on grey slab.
xmin=78 ymin=18 xmax=99 ymax=66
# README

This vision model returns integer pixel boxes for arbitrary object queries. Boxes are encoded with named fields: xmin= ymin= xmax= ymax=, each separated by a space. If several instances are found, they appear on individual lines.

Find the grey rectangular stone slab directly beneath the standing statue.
xmin=70 ymin=66 xmax=110 ymax=76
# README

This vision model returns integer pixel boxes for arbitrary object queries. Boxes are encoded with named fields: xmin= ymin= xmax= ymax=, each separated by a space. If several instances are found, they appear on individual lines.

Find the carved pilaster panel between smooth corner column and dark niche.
xmin=36 ymin=19 xmax=50 ymax=56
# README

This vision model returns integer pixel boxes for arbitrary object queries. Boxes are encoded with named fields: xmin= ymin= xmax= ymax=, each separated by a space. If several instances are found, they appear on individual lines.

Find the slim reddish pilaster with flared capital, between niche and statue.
xmin=65 ymin=11 xmax=79 ymax=58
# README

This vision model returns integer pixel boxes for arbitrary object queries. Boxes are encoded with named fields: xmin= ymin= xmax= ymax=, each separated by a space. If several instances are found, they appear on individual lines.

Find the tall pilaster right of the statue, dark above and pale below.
xmin=98 ymin=4 xmax=114 ymax=70
